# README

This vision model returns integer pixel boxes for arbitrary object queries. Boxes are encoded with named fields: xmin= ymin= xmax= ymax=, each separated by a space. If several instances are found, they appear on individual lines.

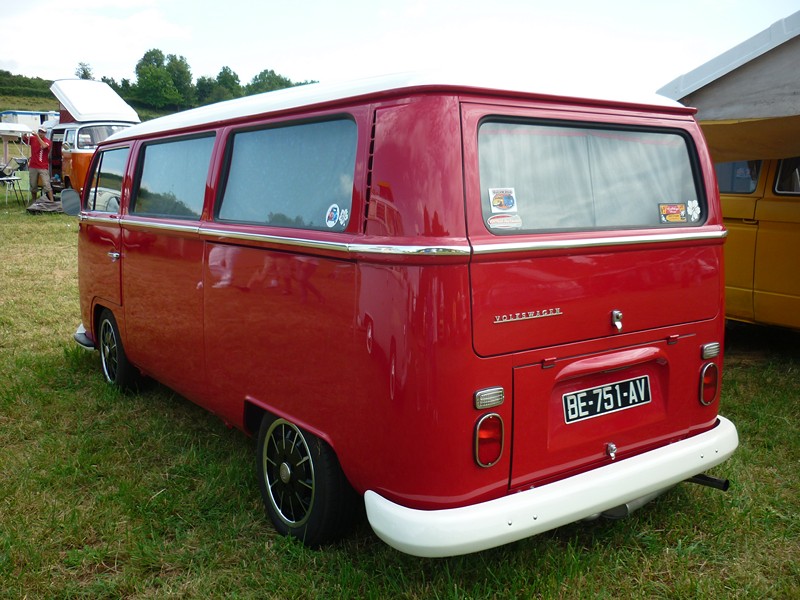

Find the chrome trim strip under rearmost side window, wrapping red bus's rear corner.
xmin=200 ymin=229 xmax=471 ymax=257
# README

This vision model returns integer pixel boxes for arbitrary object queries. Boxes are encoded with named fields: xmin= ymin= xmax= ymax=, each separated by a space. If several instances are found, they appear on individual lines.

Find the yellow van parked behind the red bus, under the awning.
xmin=716 ymin=156 xmax=800 ymax=329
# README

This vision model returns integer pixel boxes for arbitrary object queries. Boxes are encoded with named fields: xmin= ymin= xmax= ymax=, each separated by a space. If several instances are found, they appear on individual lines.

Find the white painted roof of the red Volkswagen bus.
xmin=108 ymin=71 xmax=683 ymax=140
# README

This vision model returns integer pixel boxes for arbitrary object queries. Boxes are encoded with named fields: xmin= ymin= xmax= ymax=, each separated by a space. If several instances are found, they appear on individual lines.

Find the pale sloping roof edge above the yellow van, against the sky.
xmin=657 ymin=11 xmax=800 ymax=100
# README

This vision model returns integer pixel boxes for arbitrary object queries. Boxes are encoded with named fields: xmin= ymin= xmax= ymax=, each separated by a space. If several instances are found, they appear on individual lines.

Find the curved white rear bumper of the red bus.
xmin=364 ymin=417 xmax=739 ymax=557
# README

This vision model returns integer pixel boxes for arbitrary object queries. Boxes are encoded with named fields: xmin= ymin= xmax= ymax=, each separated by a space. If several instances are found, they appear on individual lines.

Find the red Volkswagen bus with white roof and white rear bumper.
xmin=76 ymin=76 xmax=738 ymax=556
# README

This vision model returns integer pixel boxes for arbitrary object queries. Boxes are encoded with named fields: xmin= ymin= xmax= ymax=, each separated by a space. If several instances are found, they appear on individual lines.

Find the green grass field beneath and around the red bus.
xmin=0 ymin=204 xmax=800 ymax=599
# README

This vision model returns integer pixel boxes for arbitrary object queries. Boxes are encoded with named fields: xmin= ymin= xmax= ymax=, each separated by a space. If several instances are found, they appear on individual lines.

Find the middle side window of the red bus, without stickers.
xmin=131 ymin=136 xmax=214 ymax=219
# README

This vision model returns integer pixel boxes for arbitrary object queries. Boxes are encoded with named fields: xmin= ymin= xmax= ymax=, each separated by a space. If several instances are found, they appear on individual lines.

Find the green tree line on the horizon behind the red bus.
xmin=0 ymin=48 xmax=315 ymax=112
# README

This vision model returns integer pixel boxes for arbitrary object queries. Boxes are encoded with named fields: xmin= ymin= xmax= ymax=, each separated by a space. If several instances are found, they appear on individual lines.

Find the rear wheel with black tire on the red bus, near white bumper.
xmin=256 ymin=415 xmax=361 ymax=548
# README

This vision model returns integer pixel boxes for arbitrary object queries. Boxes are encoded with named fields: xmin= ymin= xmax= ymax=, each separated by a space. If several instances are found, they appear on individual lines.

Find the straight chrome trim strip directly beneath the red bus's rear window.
xmin=472 ymin=230 xmax=728 ymax=254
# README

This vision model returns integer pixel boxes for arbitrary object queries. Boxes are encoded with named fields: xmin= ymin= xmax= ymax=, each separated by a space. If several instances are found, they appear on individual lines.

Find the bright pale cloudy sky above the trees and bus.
xmin=0 ymin=0 xmax=800 ymax=93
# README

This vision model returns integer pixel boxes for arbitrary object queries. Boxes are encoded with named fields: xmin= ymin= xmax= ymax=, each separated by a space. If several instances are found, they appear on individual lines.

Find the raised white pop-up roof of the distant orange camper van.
xmin=50 ymin=79 xmax=141 ymax=123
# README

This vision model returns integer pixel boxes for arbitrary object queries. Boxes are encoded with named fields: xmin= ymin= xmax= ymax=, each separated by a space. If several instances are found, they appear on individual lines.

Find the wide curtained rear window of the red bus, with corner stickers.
xmin=478 ymin=120 xmax=705 ymax=235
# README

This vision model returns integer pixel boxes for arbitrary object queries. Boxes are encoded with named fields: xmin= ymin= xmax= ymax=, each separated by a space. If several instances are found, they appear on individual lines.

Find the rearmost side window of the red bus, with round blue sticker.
xmin=217 ymin=119 xmax=357 ymax=231
